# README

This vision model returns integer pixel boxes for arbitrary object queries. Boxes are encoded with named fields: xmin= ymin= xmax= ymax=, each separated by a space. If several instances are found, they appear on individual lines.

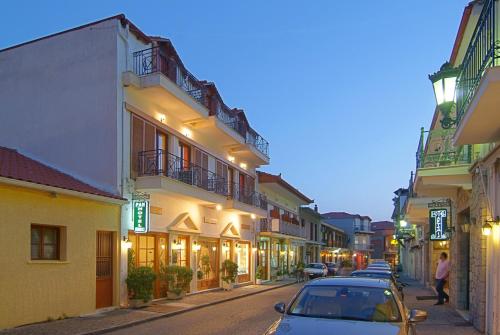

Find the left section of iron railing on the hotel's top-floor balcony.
xmin=133 ymin=47 xmax=208 ymax=108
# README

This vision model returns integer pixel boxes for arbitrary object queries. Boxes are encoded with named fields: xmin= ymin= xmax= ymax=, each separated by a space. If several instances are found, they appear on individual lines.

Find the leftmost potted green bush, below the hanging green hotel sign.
xmin=126 ymin=266 xmax=156 ymax=308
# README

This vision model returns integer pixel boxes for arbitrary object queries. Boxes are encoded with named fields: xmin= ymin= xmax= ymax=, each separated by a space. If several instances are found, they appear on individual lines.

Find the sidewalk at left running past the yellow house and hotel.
xmin=0 ymin=280 xmax=296 ymax=335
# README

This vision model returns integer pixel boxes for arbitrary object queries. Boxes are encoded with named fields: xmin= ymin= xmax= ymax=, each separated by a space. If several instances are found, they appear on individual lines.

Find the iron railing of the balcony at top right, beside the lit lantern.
xmin=457 ymin=0 xmax=500 ymax=122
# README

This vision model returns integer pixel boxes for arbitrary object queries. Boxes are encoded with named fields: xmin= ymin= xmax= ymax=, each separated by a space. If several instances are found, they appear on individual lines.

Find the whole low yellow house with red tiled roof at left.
xmin=0 ymin=147 xmax=125 ymax=329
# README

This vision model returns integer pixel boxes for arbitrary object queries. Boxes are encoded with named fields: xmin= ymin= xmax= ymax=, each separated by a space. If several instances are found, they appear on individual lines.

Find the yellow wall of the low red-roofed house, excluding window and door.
xmin=0 ymin=184 xmax=120 ymax=329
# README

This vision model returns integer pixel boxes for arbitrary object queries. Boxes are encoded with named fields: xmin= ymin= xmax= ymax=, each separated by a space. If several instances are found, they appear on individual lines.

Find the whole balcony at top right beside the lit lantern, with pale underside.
xmin=454 ymin=0 xmax=500 ymax=145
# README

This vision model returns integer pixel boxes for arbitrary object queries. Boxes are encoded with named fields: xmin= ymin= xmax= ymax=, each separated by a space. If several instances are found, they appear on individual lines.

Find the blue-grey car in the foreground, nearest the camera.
xmin=265 ymin=277 xmax=427 ymax=335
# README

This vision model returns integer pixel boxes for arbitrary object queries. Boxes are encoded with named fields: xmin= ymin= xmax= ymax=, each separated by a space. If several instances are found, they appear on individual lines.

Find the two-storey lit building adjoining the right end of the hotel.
xmin=257 ymin=171 xmax=313 ymax=280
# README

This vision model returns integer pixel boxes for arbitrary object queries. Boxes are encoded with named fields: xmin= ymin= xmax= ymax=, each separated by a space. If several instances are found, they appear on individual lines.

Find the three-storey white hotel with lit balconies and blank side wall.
xmin=0 ymin=15 xmax=269 ymax=305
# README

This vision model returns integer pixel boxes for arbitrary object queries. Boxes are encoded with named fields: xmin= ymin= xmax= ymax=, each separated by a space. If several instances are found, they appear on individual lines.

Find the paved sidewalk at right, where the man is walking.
xmin=401 ymin=278 xmax=481 ymax=335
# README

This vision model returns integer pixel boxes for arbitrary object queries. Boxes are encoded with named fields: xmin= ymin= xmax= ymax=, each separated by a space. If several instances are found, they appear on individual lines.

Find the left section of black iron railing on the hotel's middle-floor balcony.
xmin=138 ymin=149 xmax=229 ymax=196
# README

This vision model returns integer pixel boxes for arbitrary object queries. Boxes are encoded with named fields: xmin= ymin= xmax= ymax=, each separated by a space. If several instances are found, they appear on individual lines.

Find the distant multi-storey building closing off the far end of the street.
xmin=322 ymin=212 xmax=373 ymax=269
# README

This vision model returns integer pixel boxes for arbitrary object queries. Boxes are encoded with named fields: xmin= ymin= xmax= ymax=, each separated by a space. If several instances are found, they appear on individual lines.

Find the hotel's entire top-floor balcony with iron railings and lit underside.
xmin=129 ymin=47 xmax=269 ymax=164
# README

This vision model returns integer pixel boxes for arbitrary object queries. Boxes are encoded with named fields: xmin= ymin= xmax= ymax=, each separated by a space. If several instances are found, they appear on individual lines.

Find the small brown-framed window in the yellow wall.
xmin=31 ymin=225 xmax=60 ymax=260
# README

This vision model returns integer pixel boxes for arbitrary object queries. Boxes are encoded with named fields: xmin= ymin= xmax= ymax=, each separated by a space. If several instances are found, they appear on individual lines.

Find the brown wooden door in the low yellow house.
xmin=96 ymin=231 xmax=114 ymax=308
